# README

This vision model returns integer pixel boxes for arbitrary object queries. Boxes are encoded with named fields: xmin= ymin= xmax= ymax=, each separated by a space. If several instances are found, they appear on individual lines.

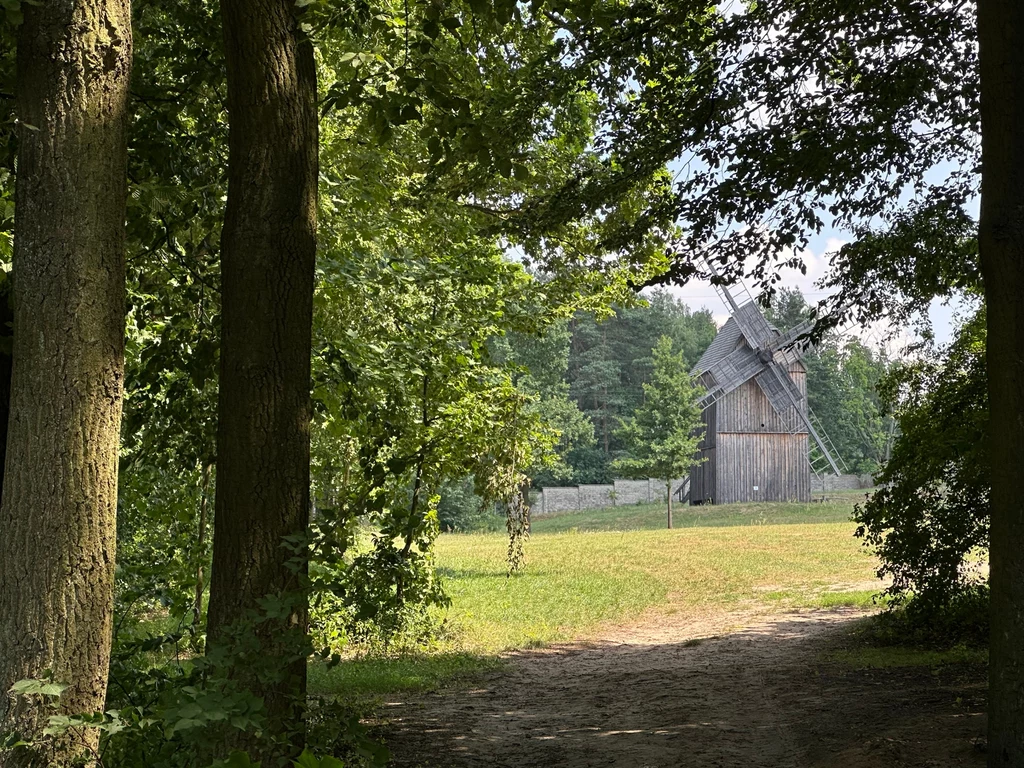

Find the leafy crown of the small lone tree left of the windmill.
xmin=613 ymin=336 xmax=703 ymax=489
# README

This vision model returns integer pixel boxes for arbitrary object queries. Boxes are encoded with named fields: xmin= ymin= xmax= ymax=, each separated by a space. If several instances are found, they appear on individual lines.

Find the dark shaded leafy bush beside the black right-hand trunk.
xmin=856 ymin=310 xmax=990 ymax=612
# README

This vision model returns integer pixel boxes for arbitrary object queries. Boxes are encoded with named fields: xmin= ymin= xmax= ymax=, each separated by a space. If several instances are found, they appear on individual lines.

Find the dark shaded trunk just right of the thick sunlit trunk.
xmin=208 ymin=0 xmax=317 ymax=759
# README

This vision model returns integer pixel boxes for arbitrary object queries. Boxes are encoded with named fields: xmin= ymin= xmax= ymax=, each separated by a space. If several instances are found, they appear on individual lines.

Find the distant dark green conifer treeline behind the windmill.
xmin=515 ymin=289 xmax=892 ymax=486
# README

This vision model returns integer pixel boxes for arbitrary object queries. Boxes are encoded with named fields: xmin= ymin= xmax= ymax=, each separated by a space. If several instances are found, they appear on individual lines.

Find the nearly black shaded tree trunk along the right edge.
xmin=978 ymin=0 xmax=1024 ymax=766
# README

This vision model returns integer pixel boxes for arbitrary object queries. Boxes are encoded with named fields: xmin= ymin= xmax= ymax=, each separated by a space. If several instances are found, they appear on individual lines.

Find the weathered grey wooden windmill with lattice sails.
xmin=690 ymin=267 xmax=841 ymax=504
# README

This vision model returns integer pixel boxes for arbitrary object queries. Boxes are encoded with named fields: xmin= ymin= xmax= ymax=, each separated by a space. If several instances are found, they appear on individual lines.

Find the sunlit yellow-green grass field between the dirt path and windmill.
xmin=310 ymin=497 xmax=881 ymax=694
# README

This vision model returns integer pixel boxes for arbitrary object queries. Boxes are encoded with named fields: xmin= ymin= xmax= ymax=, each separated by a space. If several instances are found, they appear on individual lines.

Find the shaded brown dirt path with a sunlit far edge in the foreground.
xmin=387 ymin=610 xmax=984 ymax=768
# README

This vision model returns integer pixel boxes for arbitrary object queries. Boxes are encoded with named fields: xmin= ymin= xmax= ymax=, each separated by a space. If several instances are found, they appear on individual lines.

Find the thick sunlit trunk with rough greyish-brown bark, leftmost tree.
xmin=0 ymin=0 xmax=132 ymax=768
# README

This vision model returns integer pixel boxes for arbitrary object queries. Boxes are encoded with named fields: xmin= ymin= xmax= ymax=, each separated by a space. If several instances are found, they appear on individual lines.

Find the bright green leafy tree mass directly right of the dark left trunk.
xmin=313 ymin=124 xmax=554 ymax=626
